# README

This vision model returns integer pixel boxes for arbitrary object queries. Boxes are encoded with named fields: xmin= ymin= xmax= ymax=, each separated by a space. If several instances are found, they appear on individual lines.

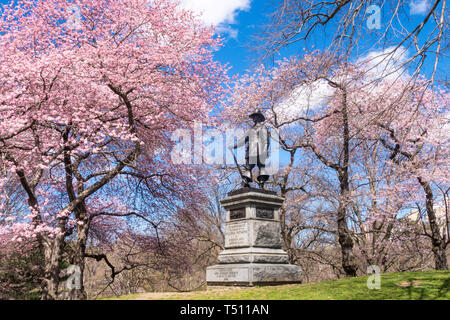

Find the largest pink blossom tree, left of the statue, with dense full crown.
xmin=0 ymin=0 xmax=225 ymax=299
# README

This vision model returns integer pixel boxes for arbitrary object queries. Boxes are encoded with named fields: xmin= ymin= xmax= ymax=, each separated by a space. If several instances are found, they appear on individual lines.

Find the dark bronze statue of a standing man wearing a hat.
xmin=229 ymin=111 xmax=270 ymax=189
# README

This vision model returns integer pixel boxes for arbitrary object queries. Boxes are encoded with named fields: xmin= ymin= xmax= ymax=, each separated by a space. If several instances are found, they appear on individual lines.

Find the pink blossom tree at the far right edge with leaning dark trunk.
xmin=358 ymin=79 xmax=450 ymax=270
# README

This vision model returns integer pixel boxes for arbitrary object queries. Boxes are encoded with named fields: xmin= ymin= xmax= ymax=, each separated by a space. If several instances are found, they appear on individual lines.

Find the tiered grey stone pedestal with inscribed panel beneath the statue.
xmin=206 ymin=188 xmax=302 ymax=286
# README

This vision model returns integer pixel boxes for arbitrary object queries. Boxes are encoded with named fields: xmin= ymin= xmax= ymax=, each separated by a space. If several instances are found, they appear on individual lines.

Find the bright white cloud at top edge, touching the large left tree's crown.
xmin=181 ymin=0 xmax=251 ymax=38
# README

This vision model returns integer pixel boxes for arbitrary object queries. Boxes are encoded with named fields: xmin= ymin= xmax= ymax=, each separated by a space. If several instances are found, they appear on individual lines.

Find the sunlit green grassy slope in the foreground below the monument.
xmin=103 ymin=271 xmax=450 ymax=300
